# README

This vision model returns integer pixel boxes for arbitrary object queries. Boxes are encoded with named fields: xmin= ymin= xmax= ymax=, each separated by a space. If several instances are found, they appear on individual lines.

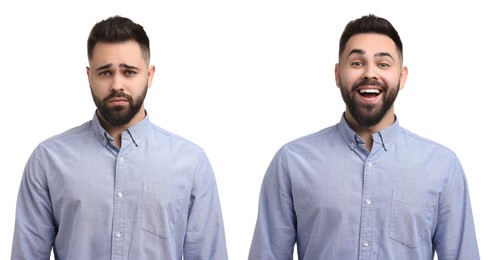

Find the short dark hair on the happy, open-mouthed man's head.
xmin=339 ymin=14 xmax=403 ymax=61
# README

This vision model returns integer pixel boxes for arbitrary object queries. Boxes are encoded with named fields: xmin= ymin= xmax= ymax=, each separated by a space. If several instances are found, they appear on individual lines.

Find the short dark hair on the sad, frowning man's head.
xmin=87 ymin=15 xmax=150 ymax=63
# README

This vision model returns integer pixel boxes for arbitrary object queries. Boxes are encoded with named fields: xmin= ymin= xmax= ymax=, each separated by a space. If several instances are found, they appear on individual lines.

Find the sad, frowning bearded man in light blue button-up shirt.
xmin=11 ymin=16 xmax=227 ymax=260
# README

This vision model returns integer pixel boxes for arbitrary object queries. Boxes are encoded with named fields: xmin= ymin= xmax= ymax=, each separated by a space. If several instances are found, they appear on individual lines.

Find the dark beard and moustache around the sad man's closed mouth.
xmin=90 ymin=86 xmax=148 ymax=126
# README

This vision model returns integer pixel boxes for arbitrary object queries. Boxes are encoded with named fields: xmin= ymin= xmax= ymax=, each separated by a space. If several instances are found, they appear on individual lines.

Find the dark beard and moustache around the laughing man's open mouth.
xmin=340 ymin=80 xmax=400 ymax=127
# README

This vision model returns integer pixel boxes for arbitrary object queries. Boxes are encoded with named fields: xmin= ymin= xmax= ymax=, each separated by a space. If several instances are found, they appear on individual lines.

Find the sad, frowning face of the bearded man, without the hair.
xmin=87 ymin=41 xmax=154 ymax=126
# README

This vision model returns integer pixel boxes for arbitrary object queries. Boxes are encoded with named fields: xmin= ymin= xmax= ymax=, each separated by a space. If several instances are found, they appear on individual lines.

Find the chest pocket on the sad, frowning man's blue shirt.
xmin=141 ymin=183 xmax=185 ymax=238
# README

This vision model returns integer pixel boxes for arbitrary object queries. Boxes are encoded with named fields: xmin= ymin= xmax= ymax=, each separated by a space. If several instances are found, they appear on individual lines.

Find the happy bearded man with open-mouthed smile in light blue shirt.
xmin=249 ymin=15 xmax=479 ymax=260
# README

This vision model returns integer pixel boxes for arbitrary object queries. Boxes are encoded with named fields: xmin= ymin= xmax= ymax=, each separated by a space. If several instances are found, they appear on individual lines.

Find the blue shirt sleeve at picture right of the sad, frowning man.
xmin=184 ymin=153 xmax=228 ymax=260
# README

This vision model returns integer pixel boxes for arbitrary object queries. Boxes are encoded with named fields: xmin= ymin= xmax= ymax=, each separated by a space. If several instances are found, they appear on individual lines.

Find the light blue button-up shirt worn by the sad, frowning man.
xmin=11 ymin=114 xmax=227 ymax=260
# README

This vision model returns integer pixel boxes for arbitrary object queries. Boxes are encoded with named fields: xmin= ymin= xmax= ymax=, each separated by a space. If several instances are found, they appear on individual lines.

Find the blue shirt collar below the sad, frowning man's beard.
xmin=92 ymin=111 xmax=151 ymax=146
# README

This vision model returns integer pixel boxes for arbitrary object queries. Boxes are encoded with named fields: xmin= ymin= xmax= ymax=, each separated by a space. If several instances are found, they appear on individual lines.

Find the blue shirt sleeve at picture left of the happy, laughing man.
xmin=248 ymin=148 xmax=296 ymax=260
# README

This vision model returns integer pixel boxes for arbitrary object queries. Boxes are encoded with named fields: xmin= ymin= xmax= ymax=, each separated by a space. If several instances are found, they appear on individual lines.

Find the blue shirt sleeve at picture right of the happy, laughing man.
xmin=434 ymin=155 xmax=480 ymax=260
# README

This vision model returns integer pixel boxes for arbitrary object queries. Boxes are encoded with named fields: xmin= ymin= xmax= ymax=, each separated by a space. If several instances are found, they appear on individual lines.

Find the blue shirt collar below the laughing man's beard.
xmin=338 ymin=114 xmax=401 ymax=151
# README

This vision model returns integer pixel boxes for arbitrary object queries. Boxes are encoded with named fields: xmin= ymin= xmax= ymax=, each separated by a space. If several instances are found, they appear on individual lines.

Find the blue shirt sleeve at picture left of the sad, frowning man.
xmin=11 ymin=147 xmax=56 ymax=259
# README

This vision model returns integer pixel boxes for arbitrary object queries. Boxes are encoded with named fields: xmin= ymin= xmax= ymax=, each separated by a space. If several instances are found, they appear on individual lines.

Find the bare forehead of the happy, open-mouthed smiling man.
xmin=342 ymin=33 xmax=399 ymax=59
